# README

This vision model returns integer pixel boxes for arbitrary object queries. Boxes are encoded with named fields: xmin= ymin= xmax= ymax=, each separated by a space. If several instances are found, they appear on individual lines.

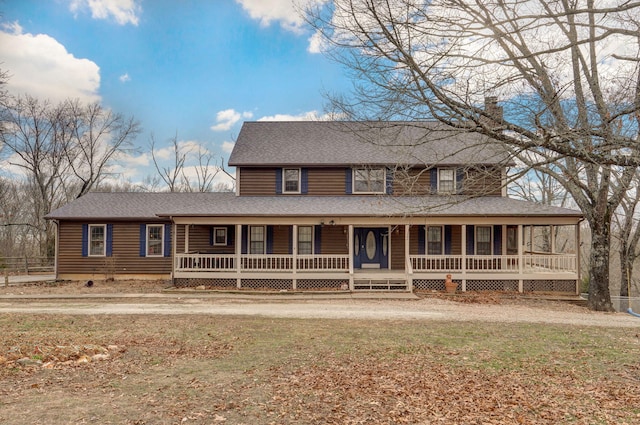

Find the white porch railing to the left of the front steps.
xmin=175 ymin=254 xmax=349 ymax=272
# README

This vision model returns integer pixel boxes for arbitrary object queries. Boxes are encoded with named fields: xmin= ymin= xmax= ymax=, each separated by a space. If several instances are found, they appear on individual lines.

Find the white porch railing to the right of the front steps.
xmin=409 ymin=254 xmax=577 ymax=273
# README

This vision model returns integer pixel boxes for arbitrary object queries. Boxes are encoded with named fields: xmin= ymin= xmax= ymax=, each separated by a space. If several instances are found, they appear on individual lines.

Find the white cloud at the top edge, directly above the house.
xmin=236 ymin=0 xmax=327 ymax=33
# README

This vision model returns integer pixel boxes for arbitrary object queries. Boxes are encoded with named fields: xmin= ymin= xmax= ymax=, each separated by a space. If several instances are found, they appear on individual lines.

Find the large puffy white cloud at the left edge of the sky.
xmin=0 ymin=22 xmax=100 ymax=102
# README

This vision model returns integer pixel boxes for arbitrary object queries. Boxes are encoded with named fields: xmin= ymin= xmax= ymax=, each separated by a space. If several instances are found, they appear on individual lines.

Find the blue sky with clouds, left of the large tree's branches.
xmin=0 ymin=0 xmax=350 ymax=189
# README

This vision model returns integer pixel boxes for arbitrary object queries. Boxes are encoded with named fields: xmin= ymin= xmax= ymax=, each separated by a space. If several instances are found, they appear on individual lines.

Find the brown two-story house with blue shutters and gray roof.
xmin=47 ymin=121 xmax=582 ymax=294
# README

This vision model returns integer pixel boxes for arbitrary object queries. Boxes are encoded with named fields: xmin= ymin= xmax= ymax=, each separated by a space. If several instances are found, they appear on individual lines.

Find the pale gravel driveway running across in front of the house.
xmin=0 ymin=294 xmax=640 ymax=330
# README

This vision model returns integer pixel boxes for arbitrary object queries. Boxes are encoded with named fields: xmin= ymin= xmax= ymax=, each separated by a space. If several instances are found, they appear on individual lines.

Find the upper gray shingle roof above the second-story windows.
xmin=229 ymin=121 xmax=509 ymax=166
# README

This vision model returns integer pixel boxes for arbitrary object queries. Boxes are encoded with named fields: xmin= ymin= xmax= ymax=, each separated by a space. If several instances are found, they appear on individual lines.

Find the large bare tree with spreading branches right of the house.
xmin=306 ymin=0 xmax=640 ymax=310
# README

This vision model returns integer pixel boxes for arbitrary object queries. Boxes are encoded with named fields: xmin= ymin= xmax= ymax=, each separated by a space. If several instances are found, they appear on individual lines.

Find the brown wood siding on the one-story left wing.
xmin=58 ymin=221 xmax=171 ymax=278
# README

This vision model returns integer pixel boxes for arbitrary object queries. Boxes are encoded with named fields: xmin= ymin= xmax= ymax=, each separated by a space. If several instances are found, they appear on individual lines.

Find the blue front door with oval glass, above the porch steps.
xmin=353 ymin=227 xmax=389 ymax=269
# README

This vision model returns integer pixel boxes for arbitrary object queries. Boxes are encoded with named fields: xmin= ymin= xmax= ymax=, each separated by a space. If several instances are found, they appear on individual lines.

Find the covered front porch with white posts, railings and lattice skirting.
xmin=173 ymin=217 xmax=579 ymax=294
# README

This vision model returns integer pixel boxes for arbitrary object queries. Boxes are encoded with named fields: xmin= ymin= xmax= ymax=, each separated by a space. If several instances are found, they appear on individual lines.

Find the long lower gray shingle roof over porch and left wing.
xmin=47 ymin=193 xmax=582 ymax=220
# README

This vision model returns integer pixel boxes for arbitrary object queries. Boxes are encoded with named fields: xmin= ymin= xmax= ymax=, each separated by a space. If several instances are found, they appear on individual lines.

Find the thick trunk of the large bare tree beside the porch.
xmin=587 ymin=219 xmax=614 ymax=311
